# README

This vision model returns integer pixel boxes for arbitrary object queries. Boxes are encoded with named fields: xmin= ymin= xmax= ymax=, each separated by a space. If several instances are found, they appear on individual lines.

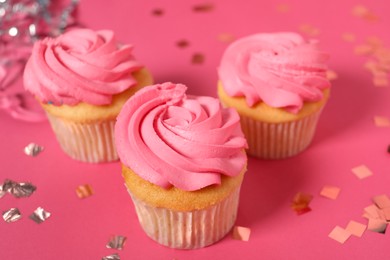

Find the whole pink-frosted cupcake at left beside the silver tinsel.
xmin=23 ymin=29 xmax=152 ymax=163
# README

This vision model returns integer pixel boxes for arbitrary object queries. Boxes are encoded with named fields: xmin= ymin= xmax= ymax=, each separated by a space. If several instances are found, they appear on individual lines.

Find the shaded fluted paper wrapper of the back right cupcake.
xmin=241 ymin=109 xmax=322 ymax=159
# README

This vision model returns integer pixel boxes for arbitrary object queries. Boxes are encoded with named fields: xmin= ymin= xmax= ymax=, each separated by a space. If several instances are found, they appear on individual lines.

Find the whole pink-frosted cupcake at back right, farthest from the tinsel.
xmin=218 ymin=32 xmax=330 ymax=159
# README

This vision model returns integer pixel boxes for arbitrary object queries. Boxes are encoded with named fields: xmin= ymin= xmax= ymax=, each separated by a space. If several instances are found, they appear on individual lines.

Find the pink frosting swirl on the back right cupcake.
xmin=218 ymin=32 xmax=330 ymax=113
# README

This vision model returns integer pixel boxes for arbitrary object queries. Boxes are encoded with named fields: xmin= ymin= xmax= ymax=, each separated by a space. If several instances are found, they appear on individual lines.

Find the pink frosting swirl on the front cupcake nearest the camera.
xmin=115 ymin=83 xmax=247 ymax=191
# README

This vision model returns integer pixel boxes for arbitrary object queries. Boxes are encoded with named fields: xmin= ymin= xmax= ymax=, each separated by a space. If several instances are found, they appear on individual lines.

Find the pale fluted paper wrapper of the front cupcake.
xmin=129 ymin=187 xmax=240 ymax=249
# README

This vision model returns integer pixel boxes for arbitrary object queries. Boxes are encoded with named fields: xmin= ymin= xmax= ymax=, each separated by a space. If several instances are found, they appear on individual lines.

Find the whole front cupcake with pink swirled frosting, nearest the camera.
xmin=115 ymin=83 xmax=247 ymax=249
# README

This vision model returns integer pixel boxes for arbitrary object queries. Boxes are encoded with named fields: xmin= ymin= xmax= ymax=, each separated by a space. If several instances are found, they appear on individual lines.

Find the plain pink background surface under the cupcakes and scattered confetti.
xmin=0 ymin=0 xmax=390 ymax=259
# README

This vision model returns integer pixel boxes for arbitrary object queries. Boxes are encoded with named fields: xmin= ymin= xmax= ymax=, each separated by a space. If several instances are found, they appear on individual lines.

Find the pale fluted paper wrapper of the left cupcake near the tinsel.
xmin=47 ymin=113 xmax=118 ymax=163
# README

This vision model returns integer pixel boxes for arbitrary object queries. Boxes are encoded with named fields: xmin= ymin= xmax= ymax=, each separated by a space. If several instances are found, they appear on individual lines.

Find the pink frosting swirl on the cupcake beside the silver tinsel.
xmin=24 ymin=29 xmax=142 ymax=105
